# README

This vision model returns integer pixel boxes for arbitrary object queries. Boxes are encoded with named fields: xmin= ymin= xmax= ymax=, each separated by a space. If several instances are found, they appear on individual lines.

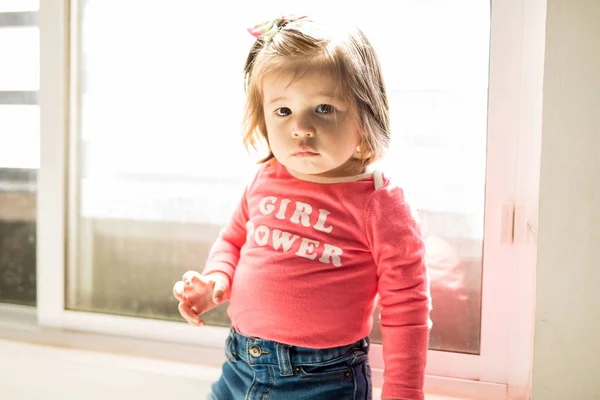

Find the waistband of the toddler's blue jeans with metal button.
xmin=226 ymin=328 xmax=370 ymax=376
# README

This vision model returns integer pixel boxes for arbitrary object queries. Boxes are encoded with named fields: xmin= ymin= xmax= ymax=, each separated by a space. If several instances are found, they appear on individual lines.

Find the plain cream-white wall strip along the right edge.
xmin=532 ymin=0 xmax=600 ymax=400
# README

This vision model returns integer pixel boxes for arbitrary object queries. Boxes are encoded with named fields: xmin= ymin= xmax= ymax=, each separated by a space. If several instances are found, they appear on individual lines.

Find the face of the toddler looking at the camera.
xmin=263 ymin=69 xmax=364 ymax=177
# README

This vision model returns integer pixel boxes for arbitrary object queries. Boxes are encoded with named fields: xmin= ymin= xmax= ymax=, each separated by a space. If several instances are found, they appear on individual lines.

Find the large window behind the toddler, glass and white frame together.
xmin=38 ymin=0 xmax=544 ymax=396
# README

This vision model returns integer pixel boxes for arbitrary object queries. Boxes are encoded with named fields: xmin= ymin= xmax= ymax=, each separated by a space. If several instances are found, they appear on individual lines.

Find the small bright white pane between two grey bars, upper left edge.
xmin=0 ymin=27 xmax=40 ymax=90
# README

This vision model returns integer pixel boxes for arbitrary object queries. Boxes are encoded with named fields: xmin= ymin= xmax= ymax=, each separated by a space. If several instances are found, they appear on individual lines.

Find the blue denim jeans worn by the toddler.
xmin=208 ymin=329 xmax=372 ymax=400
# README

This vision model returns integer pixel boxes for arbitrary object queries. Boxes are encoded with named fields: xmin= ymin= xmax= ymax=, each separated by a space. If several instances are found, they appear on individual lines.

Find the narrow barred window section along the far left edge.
xmin=0 ymin=1 xmax=40 ymax=305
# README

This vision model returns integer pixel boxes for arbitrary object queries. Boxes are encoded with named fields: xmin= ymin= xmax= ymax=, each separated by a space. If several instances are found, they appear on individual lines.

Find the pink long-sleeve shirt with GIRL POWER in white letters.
xmin=204 ymin=160 xmax=430 ymax=400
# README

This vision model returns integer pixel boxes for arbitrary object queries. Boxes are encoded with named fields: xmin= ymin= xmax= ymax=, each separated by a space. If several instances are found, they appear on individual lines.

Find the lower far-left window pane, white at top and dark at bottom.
xmin=0 ymin=115 xmax=40 ymax=305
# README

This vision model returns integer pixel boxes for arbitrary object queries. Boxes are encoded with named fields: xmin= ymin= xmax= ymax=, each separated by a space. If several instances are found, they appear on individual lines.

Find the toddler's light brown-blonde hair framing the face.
xmin=243 ymin=19 xmax=390 ymax=165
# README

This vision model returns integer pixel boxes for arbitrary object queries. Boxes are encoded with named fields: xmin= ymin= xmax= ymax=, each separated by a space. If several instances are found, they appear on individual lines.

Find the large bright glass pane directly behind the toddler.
xmin=67 ymin=0 xmax=490 ymax=353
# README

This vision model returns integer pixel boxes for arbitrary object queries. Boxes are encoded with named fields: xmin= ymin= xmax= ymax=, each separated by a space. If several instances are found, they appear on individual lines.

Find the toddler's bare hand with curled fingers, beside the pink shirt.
xmin=173 ymin=271 xmax=229 ymax=326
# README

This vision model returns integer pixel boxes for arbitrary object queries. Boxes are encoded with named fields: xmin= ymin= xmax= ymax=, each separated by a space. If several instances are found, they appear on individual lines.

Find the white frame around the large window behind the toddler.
xmin=37 ymin=0 xmax=546 ymax=399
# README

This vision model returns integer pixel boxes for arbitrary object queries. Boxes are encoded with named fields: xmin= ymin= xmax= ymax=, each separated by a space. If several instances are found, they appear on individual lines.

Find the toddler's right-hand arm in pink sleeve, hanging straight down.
xmin=367 ymin=186 xmax=431 ymax=400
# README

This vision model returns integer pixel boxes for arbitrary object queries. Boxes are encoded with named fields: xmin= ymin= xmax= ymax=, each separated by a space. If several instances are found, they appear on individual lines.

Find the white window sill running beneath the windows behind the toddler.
xmin=0 ymin=304 xmax=506 ymax=400
